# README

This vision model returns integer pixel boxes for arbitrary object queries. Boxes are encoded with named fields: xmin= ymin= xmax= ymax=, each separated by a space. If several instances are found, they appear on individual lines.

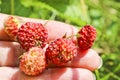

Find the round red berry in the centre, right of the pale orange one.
xmin=45 ymin=38 xmax=77 ymax=66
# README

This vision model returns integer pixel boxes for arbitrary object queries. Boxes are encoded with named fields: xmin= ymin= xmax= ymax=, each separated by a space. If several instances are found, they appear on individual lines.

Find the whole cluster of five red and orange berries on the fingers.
xmin=4 ymin=16 xmax=97 ymax=75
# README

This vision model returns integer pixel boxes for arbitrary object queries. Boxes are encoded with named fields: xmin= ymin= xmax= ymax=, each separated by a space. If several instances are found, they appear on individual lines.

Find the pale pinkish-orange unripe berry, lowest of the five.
xmin=19 ymin=47 xmax=46 ymax=75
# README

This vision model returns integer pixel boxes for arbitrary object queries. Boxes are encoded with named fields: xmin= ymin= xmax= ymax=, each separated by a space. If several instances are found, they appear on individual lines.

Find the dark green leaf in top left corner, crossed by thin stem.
xmin=0 ymin=0 xmax=30 ymax=16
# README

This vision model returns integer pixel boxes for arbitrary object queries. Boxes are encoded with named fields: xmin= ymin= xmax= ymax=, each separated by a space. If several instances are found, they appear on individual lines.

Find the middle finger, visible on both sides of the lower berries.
xmin=0 ymin=41 xmax=101 ymax=70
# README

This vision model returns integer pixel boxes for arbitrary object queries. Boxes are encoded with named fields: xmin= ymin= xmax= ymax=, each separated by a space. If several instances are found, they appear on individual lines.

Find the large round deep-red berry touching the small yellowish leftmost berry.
xmin=17 ymin=22 xmax=48 ymax=50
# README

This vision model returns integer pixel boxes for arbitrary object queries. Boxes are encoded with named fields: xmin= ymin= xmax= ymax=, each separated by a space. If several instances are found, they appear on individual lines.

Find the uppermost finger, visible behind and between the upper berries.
xmin=0 ymin=14 xmax=78 ymax=41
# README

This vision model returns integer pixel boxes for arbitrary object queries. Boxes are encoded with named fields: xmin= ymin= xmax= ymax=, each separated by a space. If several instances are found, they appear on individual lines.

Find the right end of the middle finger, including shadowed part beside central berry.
xmin=66 ymin=49 xmax=102 ymax=71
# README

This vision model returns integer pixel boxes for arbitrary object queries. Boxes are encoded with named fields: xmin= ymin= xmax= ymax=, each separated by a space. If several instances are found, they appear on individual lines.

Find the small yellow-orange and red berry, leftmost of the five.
xmin=4 ymin=16 xmax=20 ymax=40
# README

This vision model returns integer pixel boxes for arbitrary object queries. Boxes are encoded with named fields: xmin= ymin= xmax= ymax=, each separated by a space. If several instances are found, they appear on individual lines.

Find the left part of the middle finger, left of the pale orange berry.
xmin=0 ymin=41 xmax=22 ymax=66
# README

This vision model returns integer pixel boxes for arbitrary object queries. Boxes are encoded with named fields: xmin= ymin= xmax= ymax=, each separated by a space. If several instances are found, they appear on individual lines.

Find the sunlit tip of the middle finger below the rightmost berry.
xmin=79 ymin=49 xmax=101 ymax=71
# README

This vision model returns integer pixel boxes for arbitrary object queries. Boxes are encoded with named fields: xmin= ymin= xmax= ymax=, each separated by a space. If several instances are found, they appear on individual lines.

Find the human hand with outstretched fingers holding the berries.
xmin=0 ymin=14 xmax=101 ymax=80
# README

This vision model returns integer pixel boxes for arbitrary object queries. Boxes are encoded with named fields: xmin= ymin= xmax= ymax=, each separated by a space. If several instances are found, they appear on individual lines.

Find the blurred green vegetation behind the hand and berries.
xmin=0 ymin=0 xmax=120 ymax=80
